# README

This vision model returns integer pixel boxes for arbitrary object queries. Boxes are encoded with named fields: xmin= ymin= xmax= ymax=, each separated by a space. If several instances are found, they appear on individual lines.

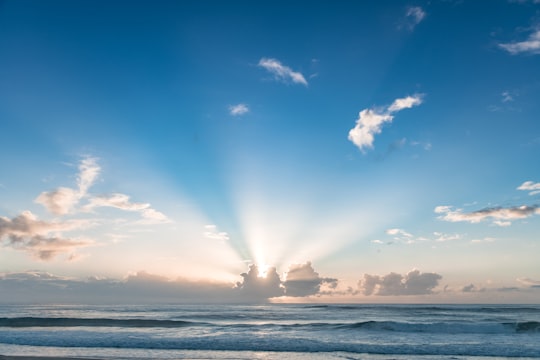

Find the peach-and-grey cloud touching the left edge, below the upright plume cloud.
xmin=0 ymin=211 xmax=92 ymax=260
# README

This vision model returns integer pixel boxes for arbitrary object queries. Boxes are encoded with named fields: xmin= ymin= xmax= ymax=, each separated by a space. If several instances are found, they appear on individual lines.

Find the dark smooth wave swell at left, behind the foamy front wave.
xmin=0 ymin=317 xmax=198 ymax=328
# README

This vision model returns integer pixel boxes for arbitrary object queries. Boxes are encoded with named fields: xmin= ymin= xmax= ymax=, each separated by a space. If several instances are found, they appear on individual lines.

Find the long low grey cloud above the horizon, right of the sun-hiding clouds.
xmin=358 ymin=270 xmax=442 ymax=296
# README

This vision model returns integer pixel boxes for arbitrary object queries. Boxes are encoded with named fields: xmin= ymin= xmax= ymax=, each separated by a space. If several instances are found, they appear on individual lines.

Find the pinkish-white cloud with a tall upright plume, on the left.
xmin=35 ymin=157 xmax=101 ymax=215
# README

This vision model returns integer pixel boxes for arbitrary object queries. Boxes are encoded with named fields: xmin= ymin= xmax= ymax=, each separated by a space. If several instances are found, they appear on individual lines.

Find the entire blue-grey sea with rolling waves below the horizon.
xmin=0 ymin=304 xmax=540 ymax=360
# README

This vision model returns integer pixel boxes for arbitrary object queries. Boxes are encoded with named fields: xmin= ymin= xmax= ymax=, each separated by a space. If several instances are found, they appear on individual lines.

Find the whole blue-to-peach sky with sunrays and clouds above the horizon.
xmin=0 ymin=0 xmax=540 ymax=303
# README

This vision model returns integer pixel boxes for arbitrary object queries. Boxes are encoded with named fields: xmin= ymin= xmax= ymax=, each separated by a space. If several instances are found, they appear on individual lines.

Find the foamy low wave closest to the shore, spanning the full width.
xmin=0 ymin=330 xmax=540 ymax=358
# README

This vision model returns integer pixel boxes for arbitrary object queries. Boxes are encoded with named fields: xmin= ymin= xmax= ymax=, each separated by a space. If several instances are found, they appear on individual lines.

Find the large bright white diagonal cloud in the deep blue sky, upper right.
xmin=348 ymin=94 xmax=422 ymax=152
